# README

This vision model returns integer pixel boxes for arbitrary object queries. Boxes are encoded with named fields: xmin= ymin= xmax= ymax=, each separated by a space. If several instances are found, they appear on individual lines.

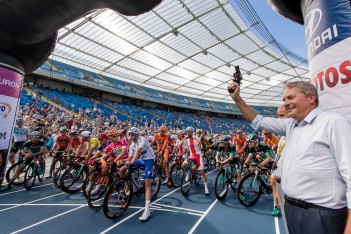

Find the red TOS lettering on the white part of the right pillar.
xmin=312 ymin=60 xmax=351 ymax=92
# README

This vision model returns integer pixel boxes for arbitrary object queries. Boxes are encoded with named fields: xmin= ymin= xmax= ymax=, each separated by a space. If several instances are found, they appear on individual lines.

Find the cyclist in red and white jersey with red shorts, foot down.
xmin=182 ymin=126 xmax=210 ymax=195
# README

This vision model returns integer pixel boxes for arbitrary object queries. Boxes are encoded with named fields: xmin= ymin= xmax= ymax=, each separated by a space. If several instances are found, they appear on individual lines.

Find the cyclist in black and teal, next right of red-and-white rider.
xmin=216 ymin=136 xmax=241 ymax=183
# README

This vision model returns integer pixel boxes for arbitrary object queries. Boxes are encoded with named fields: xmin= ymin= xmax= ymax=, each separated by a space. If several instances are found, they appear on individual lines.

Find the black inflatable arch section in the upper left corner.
xmin=0 ymin=0 xmax=162 ymax=73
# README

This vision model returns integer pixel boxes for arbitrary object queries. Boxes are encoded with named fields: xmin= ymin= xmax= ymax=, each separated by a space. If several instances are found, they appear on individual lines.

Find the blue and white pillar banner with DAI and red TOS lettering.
xmin=302 ymin=0 xmax=351 ymax=121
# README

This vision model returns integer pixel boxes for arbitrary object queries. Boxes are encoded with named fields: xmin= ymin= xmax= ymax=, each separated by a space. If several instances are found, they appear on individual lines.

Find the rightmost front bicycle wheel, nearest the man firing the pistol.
xmin=238 ymin=174 xmax=262 ymax=206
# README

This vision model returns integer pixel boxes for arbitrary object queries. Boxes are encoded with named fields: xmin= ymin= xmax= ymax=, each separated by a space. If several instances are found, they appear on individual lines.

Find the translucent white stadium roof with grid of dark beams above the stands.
xmin=51 ymin=0 xmax=309 ymax=106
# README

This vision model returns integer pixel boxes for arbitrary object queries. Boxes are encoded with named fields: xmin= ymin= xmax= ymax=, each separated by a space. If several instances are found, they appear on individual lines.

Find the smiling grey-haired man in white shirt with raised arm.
xmin=228 ymin=81 xmax=351 ymax=234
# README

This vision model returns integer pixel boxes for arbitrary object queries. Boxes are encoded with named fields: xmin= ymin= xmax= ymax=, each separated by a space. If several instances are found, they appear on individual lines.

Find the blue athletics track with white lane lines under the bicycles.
xmin=0 ymin=166 xmax=285 ymax=234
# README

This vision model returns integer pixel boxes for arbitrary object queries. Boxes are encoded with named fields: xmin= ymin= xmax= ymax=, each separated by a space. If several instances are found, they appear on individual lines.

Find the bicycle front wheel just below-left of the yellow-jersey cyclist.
xmin=60 ymin=165 xmax=87 ymax=194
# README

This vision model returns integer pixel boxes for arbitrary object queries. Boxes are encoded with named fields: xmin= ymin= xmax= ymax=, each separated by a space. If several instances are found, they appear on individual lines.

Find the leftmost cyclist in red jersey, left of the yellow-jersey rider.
xmin=45 ymin=127 xmax=71 ymax=179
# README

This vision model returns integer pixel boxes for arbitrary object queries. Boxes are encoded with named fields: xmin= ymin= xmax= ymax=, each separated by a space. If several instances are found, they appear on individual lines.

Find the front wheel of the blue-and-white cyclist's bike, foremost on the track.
xmin=103 ymin=179 xmax=133 ymax=219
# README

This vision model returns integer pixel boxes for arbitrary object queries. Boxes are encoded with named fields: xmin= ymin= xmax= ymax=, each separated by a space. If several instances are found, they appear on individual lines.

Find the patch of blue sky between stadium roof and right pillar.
xmin=230 ymin=0 xmax=307 ymax=58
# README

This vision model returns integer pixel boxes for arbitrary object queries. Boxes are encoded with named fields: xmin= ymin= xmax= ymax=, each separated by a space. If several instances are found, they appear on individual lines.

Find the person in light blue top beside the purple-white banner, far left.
xmin=9 ymin=117 xmax=29 ymax=165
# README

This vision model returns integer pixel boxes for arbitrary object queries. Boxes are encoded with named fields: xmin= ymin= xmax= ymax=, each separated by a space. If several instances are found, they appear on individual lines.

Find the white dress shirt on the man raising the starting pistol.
xmin=252 ymin=108 xmax=351 ymax=209
